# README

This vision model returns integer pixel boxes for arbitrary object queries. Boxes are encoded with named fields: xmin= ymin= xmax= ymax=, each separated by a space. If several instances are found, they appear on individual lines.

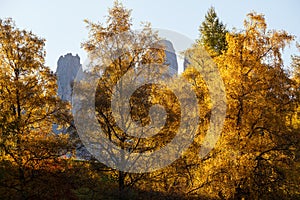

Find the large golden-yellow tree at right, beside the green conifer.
xmin=185 ymin=13 xmax=297 ymax=199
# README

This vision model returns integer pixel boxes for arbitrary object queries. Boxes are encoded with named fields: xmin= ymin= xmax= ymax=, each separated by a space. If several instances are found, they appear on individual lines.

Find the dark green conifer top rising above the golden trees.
xmin=198 ymin=7 xmax=228 ymax=57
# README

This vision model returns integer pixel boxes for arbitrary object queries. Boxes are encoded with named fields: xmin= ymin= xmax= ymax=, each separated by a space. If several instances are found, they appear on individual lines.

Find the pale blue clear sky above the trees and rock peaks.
xmin=0 ymin=0 xmax=300 ymax=71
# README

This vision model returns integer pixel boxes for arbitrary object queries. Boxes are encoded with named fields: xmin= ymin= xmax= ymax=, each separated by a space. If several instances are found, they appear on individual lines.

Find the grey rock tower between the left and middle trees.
xmin=56 ymin=53 xmax=82 ymax=102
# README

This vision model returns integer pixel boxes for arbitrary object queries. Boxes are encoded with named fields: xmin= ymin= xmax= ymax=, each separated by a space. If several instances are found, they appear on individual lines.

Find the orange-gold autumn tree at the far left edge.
xmin=0 ymin=19 xmax=72 ymax=199
